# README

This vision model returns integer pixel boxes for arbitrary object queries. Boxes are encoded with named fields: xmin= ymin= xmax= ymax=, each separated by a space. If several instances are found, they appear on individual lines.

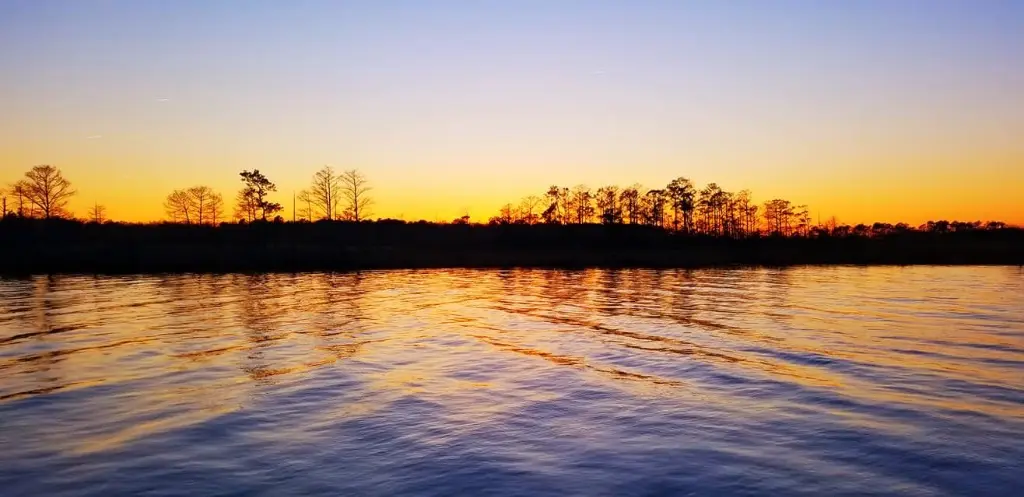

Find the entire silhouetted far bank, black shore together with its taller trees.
xmin=0 ymin=165 xmax=1024 ymax=274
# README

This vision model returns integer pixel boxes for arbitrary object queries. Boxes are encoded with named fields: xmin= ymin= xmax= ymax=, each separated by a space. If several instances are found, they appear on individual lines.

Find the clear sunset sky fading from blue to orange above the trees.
xmin=0 ymin=0 xmax=1024 ymax=223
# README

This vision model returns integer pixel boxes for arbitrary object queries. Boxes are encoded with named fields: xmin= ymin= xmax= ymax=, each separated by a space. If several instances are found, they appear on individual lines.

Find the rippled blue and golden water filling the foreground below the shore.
xmin=0 ymin=267 xmax=1024 ymax=496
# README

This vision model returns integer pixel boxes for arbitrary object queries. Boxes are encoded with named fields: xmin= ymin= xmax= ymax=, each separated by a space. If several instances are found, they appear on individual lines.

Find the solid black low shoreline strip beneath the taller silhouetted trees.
xmin=0 ymin=217 xmax=1024 ymax=275
